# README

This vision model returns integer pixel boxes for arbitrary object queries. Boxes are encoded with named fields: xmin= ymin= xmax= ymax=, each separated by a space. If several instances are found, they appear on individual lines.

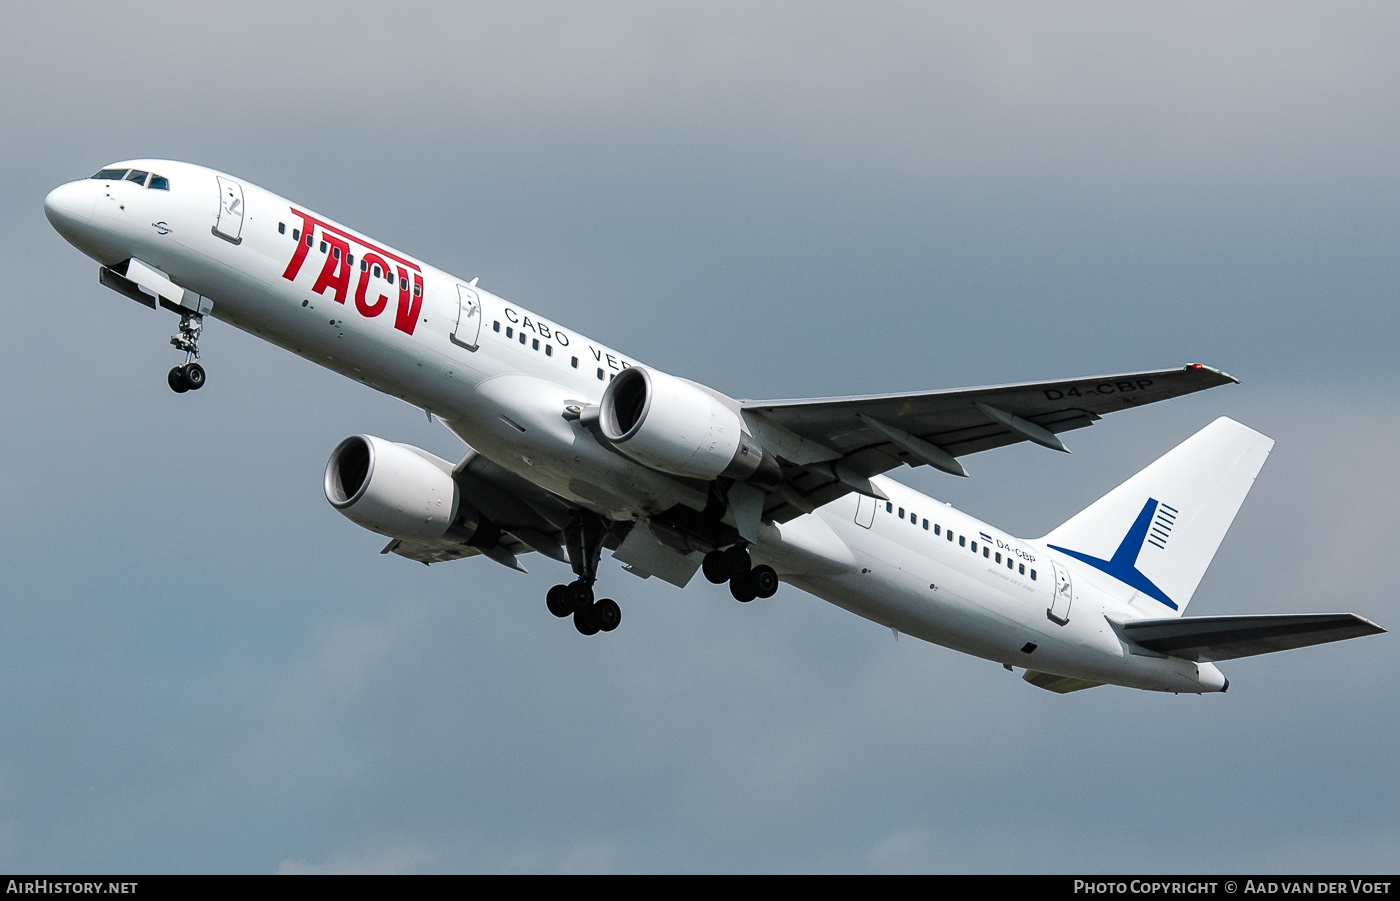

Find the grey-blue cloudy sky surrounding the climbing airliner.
xmin=0 ymin=3 xmax=1400 ymax=873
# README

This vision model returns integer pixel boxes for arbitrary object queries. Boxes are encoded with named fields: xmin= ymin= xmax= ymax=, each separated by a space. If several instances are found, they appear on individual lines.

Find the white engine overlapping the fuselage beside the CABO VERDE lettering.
xmin=598 ymin=367 xmax=781 ymax=480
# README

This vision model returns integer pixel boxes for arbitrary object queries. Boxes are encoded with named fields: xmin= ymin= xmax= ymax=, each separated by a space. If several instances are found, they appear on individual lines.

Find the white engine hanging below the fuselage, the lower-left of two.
xmin=326 ymin=435 xmax=480 ymax=540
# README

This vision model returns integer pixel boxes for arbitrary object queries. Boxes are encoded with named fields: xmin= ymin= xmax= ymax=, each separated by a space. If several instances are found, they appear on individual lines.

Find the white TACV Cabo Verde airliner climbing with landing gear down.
xmin=43 ymin=159 xmax=1385 ymax=694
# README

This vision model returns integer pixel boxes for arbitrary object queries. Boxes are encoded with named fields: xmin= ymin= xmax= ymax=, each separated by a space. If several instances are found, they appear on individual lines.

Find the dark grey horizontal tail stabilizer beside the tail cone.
xmin=1117 ymin=613 xmax=1386 ymax=663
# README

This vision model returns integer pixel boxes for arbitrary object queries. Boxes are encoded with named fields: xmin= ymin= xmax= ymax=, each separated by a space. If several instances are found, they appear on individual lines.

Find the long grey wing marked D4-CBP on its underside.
xmin=742 ymin=364 xmax=1239 ymax=522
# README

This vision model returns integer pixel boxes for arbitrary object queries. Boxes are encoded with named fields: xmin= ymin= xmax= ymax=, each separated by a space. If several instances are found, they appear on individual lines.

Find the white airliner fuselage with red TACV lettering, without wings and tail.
xmin=46 ymin=159 xmax=1225 ymax=693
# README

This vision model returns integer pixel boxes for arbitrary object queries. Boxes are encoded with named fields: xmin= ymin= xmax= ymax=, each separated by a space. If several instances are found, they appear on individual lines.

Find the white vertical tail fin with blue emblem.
xmin=1042 ymin=417 xmax=1274 ymax=616
